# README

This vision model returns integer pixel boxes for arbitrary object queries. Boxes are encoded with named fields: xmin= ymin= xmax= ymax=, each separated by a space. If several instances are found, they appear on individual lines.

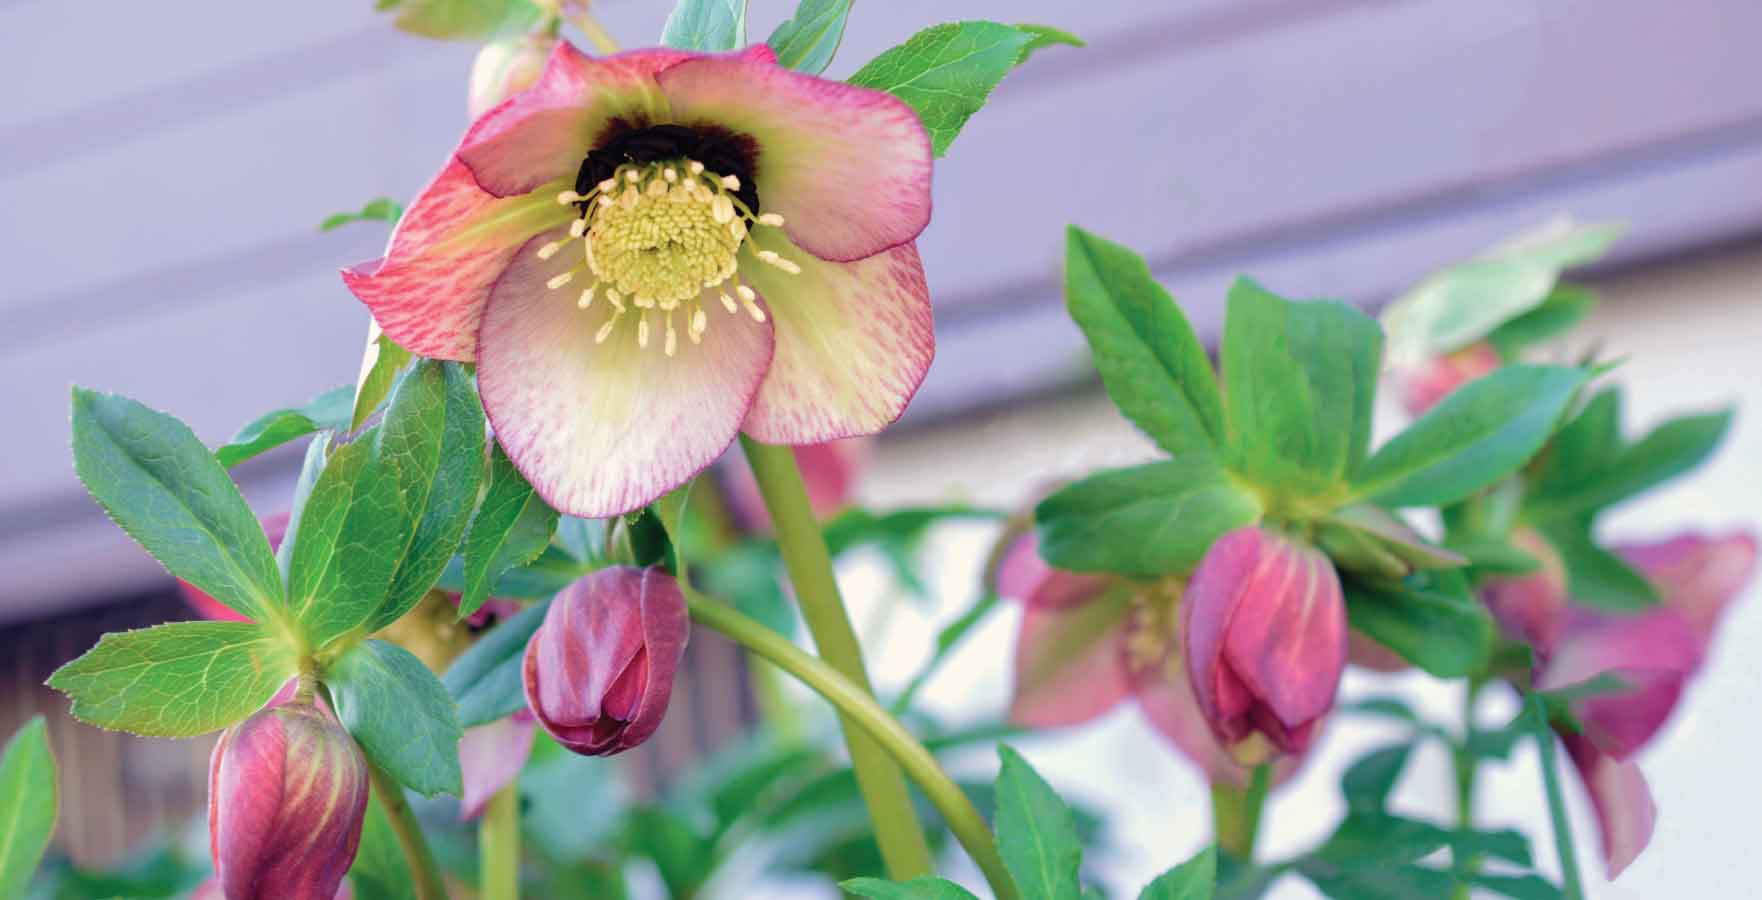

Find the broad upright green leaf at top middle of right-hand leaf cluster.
xmin=1221 ymin=278 xmax=1383 ymax=495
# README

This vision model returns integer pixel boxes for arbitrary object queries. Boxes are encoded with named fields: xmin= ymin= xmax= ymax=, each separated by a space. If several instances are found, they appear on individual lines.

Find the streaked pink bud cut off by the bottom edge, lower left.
xmin=208 ymin=703 xmax=368 ymax=900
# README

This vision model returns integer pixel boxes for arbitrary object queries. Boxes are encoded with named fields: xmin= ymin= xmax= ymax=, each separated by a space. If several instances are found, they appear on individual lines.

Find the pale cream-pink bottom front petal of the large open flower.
xmin=478 ymin=232 xmax=774 ymax=518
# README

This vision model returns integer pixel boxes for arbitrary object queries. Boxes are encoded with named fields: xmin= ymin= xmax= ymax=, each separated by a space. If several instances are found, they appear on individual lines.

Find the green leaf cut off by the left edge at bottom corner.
xmin=0 ymin=715 xmax=58 ymax=896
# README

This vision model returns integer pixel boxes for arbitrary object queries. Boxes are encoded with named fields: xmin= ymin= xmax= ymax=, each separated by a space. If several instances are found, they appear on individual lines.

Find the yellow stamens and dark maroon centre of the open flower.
xmin=521 ymin=127 xmax=802 ymax=356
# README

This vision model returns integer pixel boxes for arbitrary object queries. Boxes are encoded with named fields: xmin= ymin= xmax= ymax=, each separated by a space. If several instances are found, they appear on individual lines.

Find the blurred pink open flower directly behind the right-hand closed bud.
xmin=997 ymin=534 xmax=1297 ymax=784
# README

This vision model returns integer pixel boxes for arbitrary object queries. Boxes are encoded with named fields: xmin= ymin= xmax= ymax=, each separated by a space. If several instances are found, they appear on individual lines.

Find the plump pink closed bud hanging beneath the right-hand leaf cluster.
xmin=1182 ymin=527 xmax=1346 ymax=764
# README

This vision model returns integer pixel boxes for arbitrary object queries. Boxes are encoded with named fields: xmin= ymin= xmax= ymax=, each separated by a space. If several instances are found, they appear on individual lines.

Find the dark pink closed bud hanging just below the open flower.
xmin=523 ymin=565 xmax=691 ymax=756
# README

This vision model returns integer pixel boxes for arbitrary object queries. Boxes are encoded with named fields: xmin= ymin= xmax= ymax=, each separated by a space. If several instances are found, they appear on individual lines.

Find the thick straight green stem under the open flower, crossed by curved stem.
xmin=740 ymin=435 xmax=934 ymax=881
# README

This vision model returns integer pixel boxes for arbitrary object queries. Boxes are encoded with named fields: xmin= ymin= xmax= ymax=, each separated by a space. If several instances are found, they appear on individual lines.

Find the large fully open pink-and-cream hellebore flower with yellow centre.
xmin=344 ymin=42 xmax=934 ymax=518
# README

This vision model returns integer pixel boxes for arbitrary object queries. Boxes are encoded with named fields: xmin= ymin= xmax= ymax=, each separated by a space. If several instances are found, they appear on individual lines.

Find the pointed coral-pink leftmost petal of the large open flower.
xmin=342 ymin=159 xmax=573 ymax=361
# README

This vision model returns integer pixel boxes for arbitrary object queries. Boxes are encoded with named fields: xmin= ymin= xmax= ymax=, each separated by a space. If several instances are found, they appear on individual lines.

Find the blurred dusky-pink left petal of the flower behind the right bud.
xmin=1010 ymin=588 xmax=1129 ymax=727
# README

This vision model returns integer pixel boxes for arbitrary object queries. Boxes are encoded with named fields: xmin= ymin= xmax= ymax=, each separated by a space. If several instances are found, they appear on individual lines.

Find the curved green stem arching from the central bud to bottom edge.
xmin=687 ymin=590 xmax=1018 ymax=900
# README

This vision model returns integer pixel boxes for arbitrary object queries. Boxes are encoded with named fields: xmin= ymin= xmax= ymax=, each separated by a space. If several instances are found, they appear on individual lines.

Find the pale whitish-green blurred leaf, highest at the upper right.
xmin=1383 ymin=220 xmax=1625 ymax=366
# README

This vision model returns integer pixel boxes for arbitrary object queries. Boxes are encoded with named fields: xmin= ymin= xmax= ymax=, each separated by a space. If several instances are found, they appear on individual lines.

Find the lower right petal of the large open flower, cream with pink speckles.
xmin=740 ymin=227 xmax=936 ymax=444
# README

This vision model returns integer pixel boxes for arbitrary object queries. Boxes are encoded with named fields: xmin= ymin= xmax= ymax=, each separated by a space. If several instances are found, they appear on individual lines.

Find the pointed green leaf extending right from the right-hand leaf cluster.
xmin=1355 ymin=366 xmax=1586 ymax=505
